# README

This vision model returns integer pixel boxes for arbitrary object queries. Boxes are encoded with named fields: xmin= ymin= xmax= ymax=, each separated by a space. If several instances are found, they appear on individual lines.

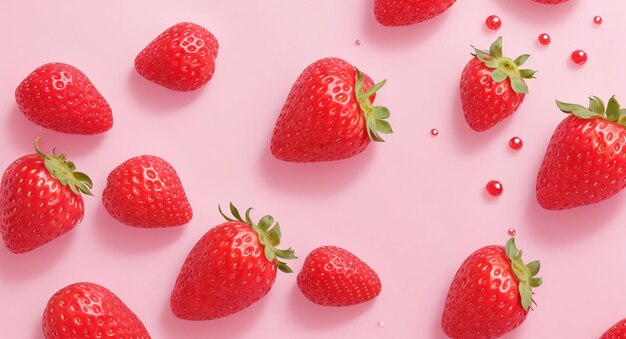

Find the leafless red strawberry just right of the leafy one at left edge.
xmin=102 ymin=155 xmax=193 ymax=227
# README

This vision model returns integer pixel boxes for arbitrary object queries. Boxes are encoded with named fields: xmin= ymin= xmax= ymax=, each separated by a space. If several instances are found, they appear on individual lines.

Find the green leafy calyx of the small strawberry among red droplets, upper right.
xmin=472 ymin=37 xmax=537 ymax=94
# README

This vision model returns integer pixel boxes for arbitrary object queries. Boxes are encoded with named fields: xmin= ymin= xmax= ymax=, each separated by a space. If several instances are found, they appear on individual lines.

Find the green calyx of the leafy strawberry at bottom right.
xmin=504 ymin=237 xmax=543 ymax=311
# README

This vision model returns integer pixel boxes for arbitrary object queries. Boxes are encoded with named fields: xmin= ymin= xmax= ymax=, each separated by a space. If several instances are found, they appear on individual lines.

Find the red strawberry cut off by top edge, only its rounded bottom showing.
xmin=374 ymin=0 xmax=456 ymax=26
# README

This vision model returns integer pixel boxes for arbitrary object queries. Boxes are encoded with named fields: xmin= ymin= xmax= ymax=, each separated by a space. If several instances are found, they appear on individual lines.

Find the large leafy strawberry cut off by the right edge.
xmin=537 ymin=96 xmax=626 ymax=210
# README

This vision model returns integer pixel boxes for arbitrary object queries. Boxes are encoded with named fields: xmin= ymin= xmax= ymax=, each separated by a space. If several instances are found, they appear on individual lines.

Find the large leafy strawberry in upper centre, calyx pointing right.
xmin=270 ymin=58 xmax=392 ymax=162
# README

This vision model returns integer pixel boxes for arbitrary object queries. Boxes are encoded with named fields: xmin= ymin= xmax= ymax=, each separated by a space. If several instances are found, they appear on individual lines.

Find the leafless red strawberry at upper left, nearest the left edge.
xmin=15 ymin=63 xmax=113 ymax=134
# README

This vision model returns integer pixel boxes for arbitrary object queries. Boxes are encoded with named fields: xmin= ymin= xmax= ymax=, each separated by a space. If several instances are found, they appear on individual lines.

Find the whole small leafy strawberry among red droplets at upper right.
xmin=461 ymin=37 xmax=535 ymax=132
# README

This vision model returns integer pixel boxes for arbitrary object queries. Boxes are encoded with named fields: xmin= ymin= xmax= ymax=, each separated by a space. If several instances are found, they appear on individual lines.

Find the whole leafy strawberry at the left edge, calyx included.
xmin=0 ymin=138 xmax=92 ymax=253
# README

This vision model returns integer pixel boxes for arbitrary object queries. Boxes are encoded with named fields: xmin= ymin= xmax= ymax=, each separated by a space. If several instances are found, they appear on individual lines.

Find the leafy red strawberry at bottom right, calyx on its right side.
xmin=441 ymin=238 xmax=542 ymax=339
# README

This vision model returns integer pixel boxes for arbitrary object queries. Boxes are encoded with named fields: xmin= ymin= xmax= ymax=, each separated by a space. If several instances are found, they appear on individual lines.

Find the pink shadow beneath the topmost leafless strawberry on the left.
xmin=125 ymin=68 xmax=204 ymax=114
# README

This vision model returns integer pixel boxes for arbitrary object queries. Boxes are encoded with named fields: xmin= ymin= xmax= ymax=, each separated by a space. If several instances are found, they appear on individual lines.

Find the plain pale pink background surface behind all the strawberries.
xmin=0 ymin=0 xmax=626 ymax=339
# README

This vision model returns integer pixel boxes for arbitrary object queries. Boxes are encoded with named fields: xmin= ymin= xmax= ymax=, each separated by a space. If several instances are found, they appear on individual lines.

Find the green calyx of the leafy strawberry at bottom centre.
xmin=217 ymin=203 xmax=298 ymax=273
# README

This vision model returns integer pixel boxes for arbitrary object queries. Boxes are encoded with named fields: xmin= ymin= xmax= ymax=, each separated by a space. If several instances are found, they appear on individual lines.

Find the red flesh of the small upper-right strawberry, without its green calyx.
xmin=461 ymin=57 xmax=524 ymax=132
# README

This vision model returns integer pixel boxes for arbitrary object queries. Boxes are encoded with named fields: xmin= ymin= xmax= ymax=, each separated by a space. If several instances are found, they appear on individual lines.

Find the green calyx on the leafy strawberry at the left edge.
xmin=35 ymin=137 xmax=93 ymax=196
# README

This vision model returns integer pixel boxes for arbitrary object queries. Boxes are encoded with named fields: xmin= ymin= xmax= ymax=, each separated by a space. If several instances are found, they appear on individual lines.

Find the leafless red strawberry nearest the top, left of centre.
xmin=135 ymin=22 xmax=219 ymax=92
